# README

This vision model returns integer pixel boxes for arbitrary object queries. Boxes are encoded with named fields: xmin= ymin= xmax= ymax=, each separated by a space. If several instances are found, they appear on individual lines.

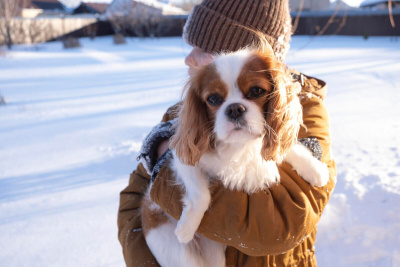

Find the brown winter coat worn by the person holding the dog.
xmin=118 ymin=74 xmax=336 ymax=267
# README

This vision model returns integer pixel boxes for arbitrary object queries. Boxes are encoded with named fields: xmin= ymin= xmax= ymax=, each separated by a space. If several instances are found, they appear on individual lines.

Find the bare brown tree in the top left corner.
xmin=0 ymin=0 xmax=26 ymax=49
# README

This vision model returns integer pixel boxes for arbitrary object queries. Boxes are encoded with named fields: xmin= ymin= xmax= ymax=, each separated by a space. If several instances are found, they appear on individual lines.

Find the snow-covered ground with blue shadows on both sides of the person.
xmin=0 ymin=36 xmax=400 ymax=267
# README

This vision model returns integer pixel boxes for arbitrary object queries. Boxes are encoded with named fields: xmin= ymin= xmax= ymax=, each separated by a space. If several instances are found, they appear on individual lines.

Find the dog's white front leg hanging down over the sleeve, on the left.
xmin=174 ymin=160 xmax=211 ymax=244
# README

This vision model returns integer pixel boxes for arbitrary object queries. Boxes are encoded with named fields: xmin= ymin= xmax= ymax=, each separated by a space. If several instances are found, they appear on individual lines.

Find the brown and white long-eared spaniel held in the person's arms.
xmin=142 ymin=45 xmax=329 ymax=267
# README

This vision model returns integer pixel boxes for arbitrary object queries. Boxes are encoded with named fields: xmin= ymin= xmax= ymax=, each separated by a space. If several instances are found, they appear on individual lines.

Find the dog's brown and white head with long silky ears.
xmin=171 ymin=48 xmax=302 ymax=168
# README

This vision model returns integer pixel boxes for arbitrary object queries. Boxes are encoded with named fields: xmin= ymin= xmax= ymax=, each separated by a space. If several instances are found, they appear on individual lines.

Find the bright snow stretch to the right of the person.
xmin=290 ymin=37 xmax=400 ymax=266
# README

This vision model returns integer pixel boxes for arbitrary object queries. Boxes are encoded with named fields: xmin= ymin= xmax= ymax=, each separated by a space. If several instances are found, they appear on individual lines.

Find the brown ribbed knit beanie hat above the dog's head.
xmin=183 ymin=0 xmax=292 ymax=61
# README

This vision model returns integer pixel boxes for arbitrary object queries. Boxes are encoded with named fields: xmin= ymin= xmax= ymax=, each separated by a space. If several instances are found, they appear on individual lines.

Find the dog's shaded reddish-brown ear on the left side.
xmin=170 ymin=74 xmax=213 ymax=166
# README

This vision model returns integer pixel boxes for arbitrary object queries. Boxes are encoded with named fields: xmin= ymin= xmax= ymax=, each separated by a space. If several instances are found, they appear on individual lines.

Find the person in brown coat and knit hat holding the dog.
xmin=118 ymin=0 xmax=336 ymax=267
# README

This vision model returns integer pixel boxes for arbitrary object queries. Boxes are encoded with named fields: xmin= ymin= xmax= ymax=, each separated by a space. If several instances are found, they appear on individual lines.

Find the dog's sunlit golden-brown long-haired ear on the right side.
xmin=261 ymin=55 xmax=302 ymax=164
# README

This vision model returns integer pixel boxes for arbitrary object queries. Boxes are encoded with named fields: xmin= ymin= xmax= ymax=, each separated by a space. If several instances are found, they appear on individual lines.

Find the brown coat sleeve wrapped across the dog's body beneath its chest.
xmin=151 ymin=87 xmax=336 ymax=256
